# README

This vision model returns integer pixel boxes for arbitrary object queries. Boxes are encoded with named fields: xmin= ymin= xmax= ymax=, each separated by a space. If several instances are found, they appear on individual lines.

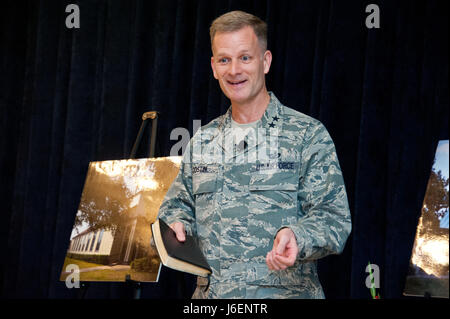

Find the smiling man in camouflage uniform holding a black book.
xmin=159 ymin=11 xmax=351 ymax=298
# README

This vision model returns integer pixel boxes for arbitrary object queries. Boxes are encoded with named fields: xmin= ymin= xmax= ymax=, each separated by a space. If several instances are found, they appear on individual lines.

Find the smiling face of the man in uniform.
xmin=211 ymin=26 xmax=272 ymax=104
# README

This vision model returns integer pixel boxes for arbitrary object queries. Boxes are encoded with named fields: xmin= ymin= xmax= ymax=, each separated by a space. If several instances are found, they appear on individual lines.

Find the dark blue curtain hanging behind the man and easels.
xmin=0 ymin=0 xmax=449 ymax=298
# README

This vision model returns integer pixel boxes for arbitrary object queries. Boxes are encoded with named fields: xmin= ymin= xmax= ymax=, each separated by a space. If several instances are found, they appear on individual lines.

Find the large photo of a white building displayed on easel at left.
xmin=60 ymin=157 xmax=181 ymax=282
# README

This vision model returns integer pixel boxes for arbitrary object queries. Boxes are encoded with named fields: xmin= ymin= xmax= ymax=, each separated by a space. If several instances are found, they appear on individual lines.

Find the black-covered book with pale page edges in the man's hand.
xmin=152 ymin=218 xmax=212 ymax=277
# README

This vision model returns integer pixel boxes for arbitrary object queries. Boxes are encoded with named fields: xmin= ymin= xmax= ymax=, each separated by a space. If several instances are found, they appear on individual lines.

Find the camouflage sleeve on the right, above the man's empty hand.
xmin=282 ymin=122 xmax=351 ymax=260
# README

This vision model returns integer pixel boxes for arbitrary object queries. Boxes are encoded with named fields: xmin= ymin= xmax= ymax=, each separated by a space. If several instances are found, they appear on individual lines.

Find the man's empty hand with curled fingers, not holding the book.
xmin=266 ymin=228 xmax=298 ymax=270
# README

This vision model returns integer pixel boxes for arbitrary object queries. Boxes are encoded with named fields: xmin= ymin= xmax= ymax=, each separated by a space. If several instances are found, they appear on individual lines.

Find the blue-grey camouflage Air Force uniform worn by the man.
xmin=159 ymin=92 xmax=351 ymax=298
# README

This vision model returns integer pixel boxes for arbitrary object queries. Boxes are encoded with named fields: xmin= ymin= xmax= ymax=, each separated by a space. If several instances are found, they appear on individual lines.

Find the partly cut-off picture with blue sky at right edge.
xmin=404 ymin=140 xmax=449 ymax=298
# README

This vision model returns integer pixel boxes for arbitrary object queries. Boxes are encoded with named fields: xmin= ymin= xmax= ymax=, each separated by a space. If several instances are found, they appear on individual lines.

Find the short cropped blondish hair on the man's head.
xmin=209 ymin=10 xmax=267 ymax=52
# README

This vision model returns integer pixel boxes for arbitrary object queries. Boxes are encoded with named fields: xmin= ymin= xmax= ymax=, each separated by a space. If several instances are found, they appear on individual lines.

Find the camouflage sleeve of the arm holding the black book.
xmin=158 ymin=143 xmax=196 ymax=235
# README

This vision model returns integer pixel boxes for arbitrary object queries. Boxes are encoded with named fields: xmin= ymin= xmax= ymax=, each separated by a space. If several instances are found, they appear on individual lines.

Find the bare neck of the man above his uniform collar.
xmin=231 ymin=90 xmax=270 ymax=124
